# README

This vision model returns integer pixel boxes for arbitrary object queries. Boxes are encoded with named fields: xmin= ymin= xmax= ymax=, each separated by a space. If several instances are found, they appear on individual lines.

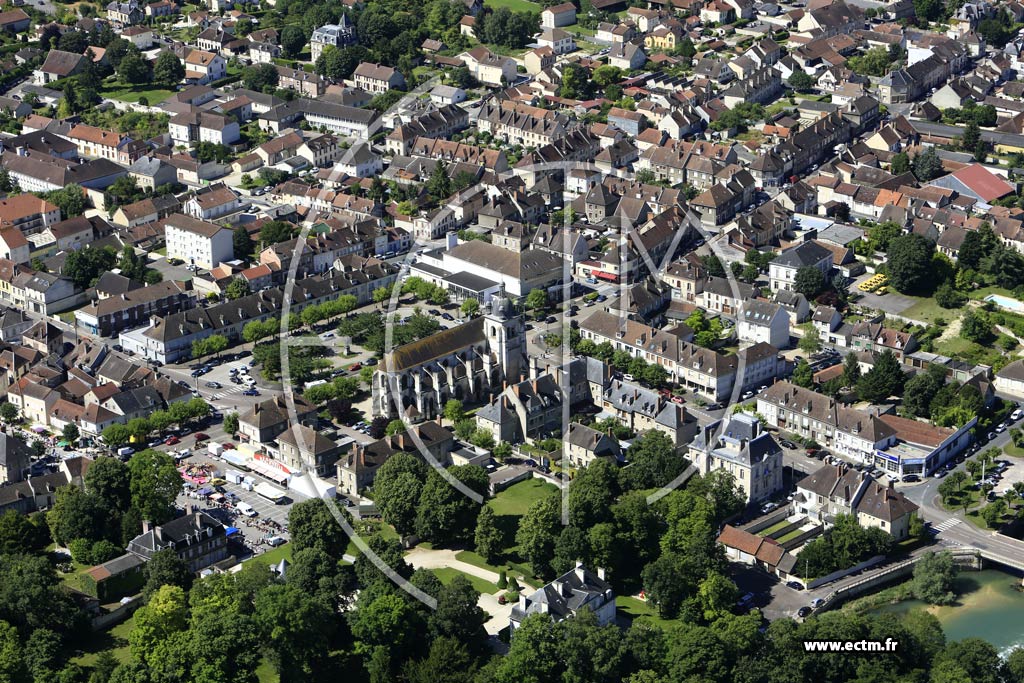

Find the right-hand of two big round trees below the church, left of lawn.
xmin=416 ymin=465 xmax=488 ymax=544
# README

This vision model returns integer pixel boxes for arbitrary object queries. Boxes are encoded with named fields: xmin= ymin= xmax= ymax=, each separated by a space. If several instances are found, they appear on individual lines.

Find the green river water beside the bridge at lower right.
xmin=871 ymin=569 xmax=1024 ymax=654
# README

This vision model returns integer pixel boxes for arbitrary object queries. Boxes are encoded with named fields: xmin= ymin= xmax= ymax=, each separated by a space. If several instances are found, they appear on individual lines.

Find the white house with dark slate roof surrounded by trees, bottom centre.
xmin=509 ymin=563 xmax=615 ymax=638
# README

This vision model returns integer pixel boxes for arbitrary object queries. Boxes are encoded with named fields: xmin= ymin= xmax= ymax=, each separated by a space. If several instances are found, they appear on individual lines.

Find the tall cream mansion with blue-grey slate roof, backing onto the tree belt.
xmin=688 ymin=413 xmax=782 ymax=503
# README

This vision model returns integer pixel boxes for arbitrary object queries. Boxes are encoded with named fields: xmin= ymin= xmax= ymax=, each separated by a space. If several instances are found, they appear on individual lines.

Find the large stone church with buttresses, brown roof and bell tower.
xmin=373 ymin=289 xmax=526 ymax=422
